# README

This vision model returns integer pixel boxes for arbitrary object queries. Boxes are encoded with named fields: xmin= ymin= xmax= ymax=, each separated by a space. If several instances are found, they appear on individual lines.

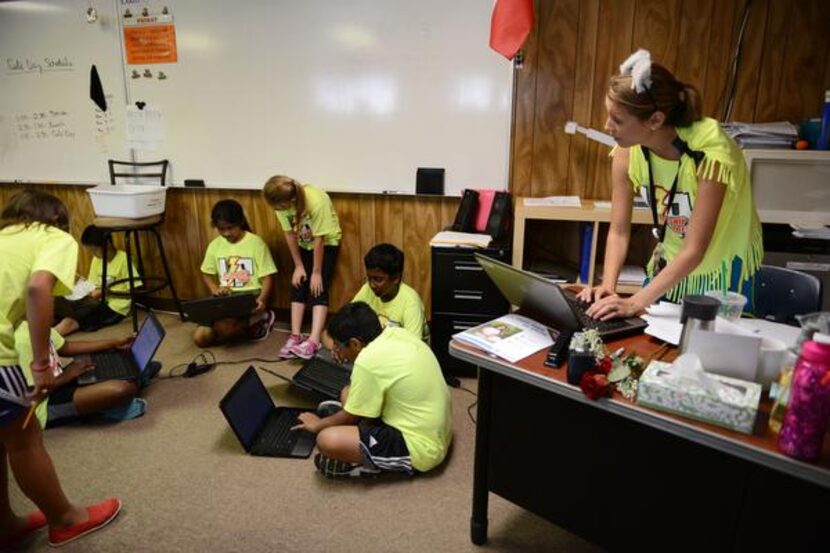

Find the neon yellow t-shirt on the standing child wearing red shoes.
xmin=0 ymin=224 xmax=78 ymax=365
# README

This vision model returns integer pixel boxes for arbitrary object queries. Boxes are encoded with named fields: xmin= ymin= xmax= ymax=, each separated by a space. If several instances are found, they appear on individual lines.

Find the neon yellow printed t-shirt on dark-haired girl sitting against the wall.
xmin=201 ymin=231 xmax=277 ymax=292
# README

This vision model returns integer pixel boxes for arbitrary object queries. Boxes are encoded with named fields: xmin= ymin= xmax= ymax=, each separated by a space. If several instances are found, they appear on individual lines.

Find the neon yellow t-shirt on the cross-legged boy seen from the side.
xmin=343 ymin=327 xmax=452 ymax=472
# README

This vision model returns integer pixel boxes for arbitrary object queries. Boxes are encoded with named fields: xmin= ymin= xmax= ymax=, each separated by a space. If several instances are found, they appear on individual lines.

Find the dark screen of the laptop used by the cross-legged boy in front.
xmin=222 ymin=367 xmax=274 ymax=451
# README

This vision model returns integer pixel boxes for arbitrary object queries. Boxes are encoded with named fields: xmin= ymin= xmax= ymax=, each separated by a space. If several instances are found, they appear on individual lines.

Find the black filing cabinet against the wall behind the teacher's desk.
xmin=431 ymin=246 xmax=510 ymax=376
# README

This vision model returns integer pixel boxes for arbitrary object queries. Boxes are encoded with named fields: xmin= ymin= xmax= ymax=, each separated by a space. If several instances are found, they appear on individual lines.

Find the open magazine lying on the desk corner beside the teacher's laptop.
xmin=453 ymin=313 xmax=553 ymax=363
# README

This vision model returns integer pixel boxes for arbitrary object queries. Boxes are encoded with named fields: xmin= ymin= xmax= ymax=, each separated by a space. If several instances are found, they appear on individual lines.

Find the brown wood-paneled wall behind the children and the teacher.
xmin=0 ymin=0 xmax=830 ymax=316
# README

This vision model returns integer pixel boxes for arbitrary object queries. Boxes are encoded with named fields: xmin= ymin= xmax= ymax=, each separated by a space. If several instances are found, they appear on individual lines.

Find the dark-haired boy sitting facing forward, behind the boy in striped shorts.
xmin=352 ymin=244 xmax=429 ymax=341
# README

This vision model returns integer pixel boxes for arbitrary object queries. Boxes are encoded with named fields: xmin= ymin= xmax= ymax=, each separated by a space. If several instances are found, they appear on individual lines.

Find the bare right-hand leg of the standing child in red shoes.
xmin=0 ymin=411 xmax=87 ymax=526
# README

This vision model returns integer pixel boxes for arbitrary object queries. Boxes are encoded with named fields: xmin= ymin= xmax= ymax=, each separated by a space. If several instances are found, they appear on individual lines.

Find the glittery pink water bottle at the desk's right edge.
xmin=778 ymin=334 xmax=830 ymax=461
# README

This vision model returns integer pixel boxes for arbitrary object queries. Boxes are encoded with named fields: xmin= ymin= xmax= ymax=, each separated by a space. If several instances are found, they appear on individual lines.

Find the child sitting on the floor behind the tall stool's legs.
xmin=55 ymin=225 xmax=141 ymax=336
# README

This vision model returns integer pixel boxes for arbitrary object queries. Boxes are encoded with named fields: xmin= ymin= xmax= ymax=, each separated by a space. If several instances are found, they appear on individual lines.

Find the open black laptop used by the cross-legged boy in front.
xmin=219 ymin=366 xmax=315 ymax=458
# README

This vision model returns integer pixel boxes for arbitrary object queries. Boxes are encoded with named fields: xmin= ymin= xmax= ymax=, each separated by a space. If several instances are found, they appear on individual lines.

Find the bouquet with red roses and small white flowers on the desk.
xmin=568 ymin=329 xmax=645 ymax=400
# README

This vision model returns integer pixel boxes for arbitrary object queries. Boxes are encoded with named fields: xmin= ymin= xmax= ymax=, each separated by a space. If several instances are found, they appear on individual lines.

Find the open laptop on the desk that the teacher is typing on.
xmin=475 ymin=254 xmax=647 ymax=341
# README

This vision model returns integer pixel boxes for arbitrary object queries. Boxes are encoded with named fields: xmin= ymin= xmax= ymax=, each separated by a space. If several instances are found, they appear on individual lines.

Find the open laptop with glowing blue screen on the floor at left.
xmin=78 ymin=313 xmax=165 ymax=384
